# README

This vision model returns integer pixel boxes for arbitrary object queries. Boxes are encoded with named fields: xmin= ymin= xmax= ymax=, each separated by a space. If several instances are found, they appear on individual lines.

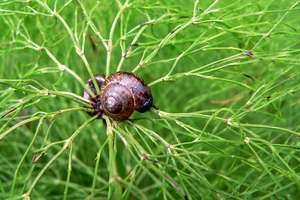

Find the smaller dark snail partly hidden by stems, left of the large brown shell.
xmin=82 ymin=74 xmax=105 ymax=117
